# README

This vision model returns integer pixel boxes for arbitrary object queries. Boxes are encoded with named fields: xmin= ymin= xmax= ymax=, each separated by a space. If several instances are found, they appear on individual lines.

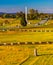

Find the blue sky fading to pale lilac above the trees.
xmin=0 ymin=0 xmax=53 ymax=13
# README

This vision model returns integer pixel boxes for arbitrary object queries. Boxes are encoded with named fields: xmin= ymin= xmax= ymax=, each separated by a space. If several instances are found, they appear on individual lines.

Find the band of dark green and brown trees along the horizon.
xmin=0 ymin=9 xmax=53 ymax=20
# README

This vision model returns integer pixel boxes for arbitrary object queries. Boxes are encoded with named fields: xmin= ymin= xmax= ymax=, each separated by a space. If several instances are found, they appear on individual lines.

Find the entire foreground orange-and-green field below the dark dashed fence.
xmin=0 ymin=44 xmax=53 ymax=65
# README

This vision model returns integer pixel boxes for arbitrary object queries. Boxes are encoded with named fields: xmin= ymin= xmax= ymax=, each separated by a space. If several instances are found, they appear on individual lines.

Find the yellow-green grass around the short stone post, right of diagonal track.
xmin=22 ymin=45 xmax=53 ymax=65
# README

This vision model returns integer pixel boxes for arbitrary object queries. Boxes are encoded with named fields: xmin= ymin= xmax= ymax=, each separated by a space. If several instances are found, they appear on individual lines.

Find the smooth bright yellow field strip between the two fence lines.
xmin=0 ymin=31 xmax=53 ymax=43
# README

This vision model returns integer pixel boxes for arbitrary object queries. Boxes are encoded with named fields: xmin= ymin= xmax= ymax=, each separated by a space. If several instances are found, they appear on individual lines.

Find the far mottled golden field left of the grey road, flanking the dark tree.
xmin=0 ymin=18 xmax=40 ymax=28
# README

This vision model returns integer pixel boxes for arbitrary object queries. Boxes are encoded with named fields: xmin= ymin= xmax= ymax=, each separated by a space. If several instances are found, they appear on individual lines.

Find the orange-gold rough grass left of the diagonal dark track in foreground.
xmin=0 ymin=46 xmax=28 ymax=65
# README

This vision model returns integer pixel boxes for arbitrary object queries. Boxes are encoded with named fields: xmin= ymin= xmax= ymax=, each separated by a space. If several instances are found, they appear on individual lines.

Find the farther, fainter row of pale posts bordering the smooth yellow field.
xmin=0 ymin=28 xmax=53 ymax=32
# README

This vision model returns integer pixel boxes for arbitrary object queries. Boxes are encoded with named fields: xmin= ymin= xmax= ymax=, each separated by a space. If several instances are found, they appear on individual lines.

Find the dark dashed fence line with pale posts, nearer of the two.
xmin=0 ymin=41 xmax=53 ymax=46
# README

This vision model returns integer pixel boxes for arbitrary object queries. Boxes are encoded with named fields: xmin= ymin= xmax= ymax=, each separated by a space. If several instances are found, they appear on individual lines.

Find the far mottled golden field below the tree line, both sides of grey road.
xmin=0 ymin=18 xmax=53 ymax=29
